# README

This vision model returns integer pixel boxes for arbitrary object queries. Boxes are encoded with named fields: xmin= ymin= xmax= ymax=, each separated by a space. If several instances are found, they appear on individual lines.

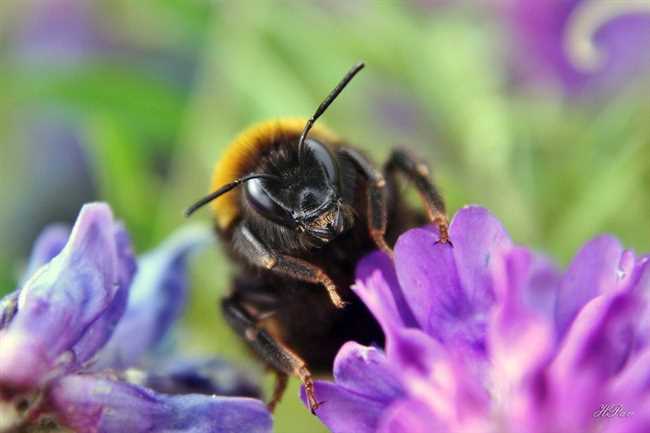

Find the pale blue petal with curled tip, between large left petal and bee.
xmin=96 ymin=226 xmax=212 ymax=368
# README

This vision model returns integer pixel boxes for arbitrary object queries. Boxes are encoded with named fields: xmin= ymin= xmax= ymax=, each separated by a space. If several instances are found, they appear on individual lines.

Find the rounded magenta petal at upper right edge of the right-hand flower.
xmin=555 ymin=235 xmax=625 ymax=335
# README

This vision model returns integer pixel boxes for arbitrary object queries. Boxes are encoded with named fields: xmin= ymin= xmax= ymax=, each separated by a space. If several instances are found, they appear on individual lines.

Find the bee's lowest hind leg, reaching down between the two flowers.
xmin=221 ymin=297 xmax=320 ymax=414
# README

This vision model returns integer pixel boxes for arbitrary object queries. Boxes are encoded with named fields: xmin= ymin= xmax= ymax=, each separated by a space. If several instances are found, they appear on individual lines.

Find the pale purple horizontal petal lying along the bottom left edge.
xmin=48 ymin=375 xmax=271 ymax=433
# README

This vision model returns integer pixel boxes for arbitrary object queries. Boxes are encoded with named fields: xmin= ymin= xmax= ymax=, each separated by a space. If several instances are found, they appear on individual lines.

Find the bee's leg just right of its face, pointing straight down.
xmin=340 ymin=147 xmax=393 ymax=257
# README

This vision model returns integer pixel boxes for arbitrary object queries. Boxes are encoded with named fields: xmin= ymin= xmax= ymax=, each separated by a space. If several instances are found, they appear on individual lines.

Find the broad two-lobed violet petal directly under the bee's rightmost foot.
xmin=395 ymin=206 xmax=511 ymax=352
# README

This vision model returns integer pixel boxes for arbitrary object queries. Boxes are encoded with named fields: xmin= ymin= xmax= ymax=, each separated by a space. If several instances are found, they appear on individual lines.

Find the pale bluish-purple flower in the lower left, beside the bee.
xmin=0 ymin=203 xmax=271 ymax=433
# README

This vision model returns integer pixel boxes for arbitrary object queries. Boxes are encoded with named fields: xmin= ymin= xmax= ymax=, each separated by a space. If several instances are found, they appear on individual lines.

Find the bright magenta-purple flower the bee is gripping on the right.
xmin=304 ymin=207 xmax=650 ymax=433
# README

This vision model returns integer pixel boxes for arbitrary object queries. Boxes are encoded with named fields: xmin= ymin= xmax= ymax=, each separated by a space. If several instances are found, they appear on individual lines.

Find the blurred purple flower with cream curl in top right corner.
xmin=499 ymin=0 xmax=650 ymax=95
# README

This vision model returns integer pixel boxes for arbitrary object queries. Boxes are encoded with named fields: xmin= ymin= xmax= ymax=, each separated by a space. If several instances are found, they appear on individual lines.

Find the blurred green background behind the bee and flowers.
xmin=0 ymin=0 xmax=650 ymax=432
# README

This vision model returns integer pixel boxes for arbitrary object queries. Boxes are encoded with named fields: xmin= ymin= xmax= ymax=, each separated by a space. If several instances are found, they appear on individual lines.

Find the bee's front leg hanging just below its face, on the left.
xmin=233 ymin=224 xmax=345 ymax=308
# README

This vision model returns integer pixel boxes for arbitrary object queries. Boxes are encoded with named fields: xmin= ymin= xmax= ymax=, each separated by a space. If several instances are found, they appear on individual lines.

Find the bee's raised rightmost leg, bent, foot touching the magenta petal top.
xmin=385 ymin=149 xmax=449 ymax=243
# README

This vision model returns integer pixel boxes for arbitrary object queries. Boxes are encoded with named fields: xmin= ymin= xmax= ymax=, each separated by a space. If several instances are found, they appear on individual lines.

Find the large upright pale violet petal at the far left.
xmin=0 ymin=203 xmax=133 ymax=388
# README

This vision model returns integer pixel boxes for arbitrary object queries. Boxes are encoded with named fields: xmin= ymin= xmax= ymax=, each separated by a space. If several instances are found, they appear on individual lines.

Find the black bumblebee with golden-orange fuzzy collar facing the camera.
xmin=186 ymin=63 xmax=448 ymax=413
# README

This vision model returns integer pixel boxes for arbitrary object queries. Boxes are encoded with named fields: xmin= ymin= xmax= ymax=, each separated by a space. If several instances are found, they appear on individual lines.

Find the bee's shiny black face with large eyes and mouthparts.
xmin=245 ymin=139 xmax=350 ymax=243
